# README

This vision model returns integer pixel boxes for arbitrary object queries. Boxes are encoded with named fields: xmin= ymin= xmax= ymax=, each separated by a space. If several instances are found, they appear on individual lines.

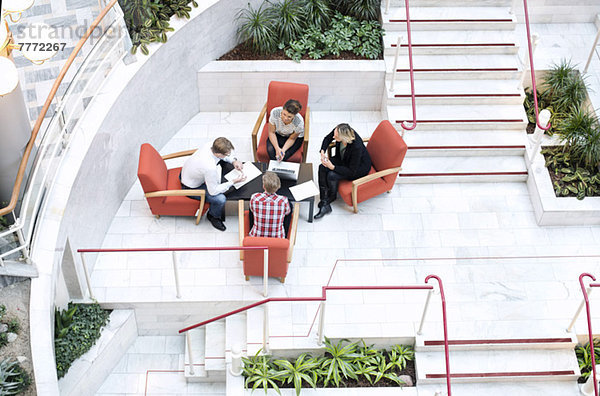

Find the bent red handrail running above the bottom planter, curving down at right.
xmin=179 ymin=275 xmax=452 ymax=396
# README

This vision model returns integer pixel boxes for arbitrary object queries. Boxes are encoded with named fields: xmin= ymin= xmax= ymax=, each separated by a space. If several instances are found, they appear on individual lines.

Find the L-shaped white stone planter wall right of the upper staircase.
xmin=526 ymin=144 xmax=600 ymax=226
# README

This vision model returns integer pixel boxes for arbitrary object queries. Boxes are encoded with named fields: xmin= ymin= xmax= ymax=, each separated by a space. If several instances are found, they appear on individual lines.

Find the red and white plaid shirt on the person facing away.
xmin=249 ymin=192 xmax=291 ymax=238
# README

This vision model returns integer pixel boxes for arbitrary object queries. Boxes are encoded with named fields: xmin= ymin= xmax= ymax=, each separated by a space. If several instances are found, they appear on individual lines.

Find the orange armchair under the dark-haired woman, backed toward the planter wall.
xmin=252 ymin=81 xmax=310 ymax=162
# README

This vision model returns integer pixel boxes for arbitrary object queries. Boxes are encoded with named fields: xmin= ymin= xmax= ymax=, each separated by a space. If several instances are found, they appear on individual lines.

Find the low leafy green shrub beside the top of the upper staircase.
xmin=285 ymin=12 xmax=383 ymax=62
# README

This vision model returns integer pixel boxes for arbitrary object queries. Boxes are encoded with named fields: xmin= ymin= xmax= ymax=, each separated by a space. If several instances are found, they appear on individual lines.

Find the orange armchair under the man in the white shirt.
xmin=138 ymin=143 xmax=209 ymax=224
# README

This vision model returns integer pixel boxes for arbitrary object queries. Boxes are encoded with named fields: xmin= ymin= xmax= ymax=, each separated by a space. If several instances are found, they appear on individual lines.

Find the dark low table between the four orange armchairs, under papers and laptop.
xmin=220 ymin=161 xmax=315 ymax=223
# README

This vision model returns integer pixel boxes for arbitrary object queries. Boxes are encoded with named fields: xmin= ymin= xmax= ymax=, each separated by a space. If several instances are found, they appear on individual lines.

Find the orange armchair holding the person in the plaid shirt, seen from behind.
xmin=238 ymin=200 xmax=300 ymax=283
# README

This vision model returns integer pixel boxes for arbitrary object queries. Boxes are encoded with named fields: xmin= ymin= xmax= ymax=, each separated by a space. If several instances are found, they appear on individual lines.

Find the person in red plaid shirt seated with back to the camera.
xmin=249 ymin=172 xmax=291 ymax=238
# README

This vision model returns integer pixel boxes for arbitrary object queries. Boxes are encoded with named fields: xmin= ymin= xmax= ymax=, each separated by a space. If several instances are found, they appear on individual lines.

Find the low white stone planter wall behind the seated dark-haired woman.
xmin=198 ymin=60 xmax=385 ymax=112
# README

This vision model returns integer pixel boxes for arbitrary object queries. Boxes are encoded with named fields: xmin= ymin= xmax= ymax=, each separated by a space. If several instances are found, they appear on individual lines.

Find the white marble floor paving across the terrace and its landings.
xmin=82 ymin=24 xmax=600 ymax=395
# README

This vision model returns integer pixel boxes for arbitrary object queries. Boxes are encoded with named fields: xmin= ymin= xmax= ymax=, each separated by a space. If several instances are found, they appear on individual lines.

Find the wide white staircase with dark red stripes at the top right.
xmin=382 ymin=0 xmax=527 ymax=183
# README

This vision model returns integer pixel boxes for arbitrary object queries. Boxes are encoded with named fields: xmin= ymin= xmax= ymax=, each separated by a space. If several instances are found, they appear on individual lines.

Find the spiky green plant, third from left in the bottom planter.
xmin=321 ymin=337 xmax=360 ymax=387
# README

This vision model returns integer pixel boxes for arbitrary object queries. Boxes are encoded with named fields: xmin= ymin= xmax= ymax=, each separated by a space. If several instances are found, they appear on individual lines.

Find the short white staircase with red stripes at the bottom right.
xmin=415 ymin=333 xmax=580 ymax=396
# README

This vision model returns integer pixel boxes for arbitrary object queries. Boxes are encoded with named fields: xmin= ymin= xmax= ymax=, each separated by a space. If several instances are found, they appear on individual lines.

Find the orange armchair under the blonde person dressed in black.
xmin=338 ymin=120 xmax=408 ymax=213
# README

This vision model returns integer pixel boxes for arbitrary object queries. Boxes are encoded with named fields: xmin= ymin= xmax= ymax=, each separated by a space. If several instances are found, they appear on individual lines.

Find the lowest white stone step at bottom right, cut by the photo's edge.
xmin=417 ymin=380 xmax=579 ymax=396
